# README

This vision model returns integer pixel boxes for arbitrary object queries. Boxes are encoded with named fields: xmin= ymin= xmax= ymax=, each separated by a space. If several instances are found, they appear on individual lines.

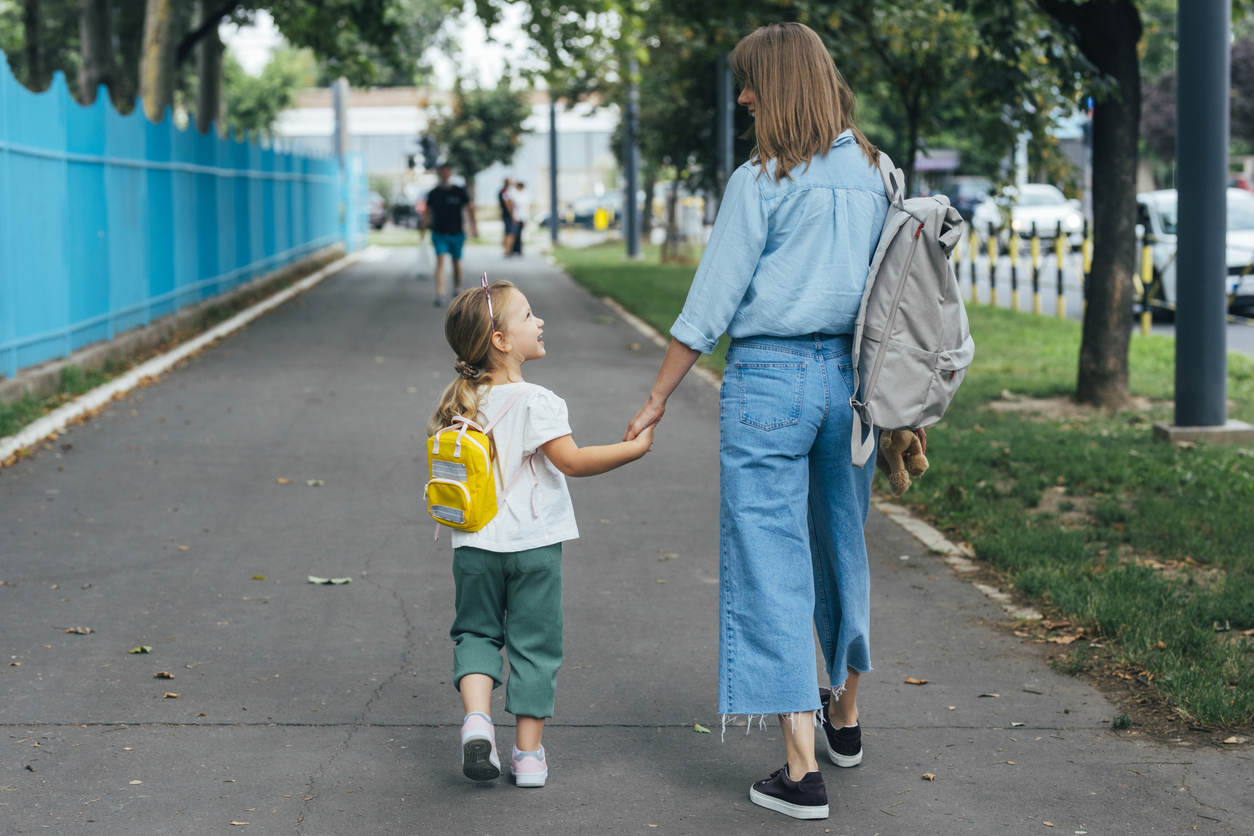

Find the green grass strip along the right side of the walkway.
xmin=557 ymin=240 xmax=1254 ymax=727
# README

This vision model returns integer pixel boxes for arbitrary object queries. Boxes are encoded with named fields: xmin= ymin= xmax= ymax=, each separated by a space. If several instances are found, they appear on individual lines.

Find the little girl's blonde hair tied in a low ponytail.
xmin=426 ymin=281 xmax=514 ymax=436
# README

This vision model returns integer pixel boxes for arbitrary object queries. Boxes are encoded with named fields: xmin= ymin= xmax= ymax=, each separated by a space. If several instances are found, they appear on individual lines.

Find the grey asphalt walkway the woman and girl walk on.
xmin=0 ymin=248 xmax=1254 ymax=836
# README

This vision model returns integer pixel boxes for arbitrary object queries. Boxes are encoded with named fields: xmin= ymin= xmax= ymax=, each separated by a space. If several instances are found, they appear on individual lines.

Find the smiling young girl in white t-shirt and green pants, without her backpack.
xmin=426 ymin=276 xmax=653 ymax=787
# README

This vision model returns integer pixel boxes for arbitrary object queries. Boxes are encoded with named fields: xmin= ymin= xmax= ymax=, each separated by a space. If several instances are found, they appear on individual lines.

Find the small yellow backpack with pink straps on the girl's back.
xmin=424 ymin=384 xmax=535 ymax=539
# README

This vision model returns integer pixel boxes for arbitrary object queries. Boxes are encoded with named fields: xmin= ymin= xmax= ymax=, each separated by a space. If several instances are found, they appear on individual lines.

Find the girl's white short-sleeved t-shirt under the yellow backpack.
xmin=453 ymin=384 xmax=579 ymax=553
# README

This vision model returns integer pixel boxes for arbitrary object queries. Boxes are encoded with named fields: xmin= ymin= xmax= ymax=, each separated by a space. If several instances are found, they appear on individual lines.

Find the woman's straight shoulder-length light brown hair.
xmin=731 ymin=23 xmax=879 ymax=183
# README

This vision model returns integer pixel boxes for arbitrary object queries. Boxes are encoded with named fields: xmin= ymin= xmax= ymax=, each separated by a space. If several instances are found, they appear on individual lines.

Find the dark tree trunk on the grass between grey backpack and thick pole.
xmin=1038 ymin=0 xmax=1141 ymax=407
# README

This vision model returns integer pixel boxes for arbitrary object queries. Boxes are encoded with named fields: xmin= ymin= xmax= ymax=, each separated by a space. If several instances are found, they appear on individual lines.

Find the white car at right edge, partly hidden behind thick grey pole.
xmin=1136 ymin=189 xmax=1254 ymax=313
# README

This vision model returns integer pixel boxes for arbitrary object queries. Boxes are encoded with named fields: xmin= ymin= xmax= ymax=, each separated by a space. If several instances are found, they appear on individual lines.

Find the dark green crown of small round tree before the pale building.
xmin=431 ymin=73 xmax=532 ymax=182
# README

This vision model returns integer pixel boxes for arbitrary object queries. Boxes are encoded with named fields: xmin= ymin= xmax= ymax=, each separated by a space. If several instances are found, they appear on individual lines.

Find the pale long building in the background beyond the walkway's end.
xmin=275 ymin=88 xmax=618 ymax=218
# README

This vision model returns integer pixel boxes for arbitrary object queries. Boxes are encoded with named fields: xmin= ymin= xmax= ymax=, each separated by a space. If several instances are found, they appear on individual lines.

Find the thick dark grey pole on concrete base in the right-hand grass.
xmin=1155 ymin=0 xmax=1254 ymax=442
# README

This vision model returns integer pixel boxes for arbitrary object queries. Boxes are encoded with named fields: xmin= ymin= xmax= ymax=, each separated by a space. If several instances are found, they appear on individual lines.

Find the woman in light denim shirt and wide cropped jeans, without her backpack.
xmin=623 ymin=24 xmax=888 ymax=818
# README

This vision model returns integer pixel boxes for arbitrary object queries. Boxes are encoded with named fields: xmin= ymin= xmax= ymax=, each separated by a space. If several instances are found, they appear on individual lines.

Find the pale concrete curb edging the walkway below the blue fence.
xmin=0 ymin=249 xmax=366 ymax=468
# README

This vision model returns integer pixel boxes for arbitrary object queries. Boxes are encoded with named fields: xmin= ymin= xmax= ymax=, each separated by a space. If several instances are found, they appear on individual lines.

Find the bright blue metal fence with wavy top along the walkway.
xmin=0 ymin=55 xmax=346 ymax=377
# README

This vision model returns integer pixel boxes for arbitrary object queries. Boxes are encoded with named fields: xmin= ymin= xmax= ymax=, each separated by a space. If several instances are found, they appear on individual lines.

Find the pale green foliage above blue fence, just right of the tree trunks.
xmin=222 ymin=49 xmax=314 ymax=137
